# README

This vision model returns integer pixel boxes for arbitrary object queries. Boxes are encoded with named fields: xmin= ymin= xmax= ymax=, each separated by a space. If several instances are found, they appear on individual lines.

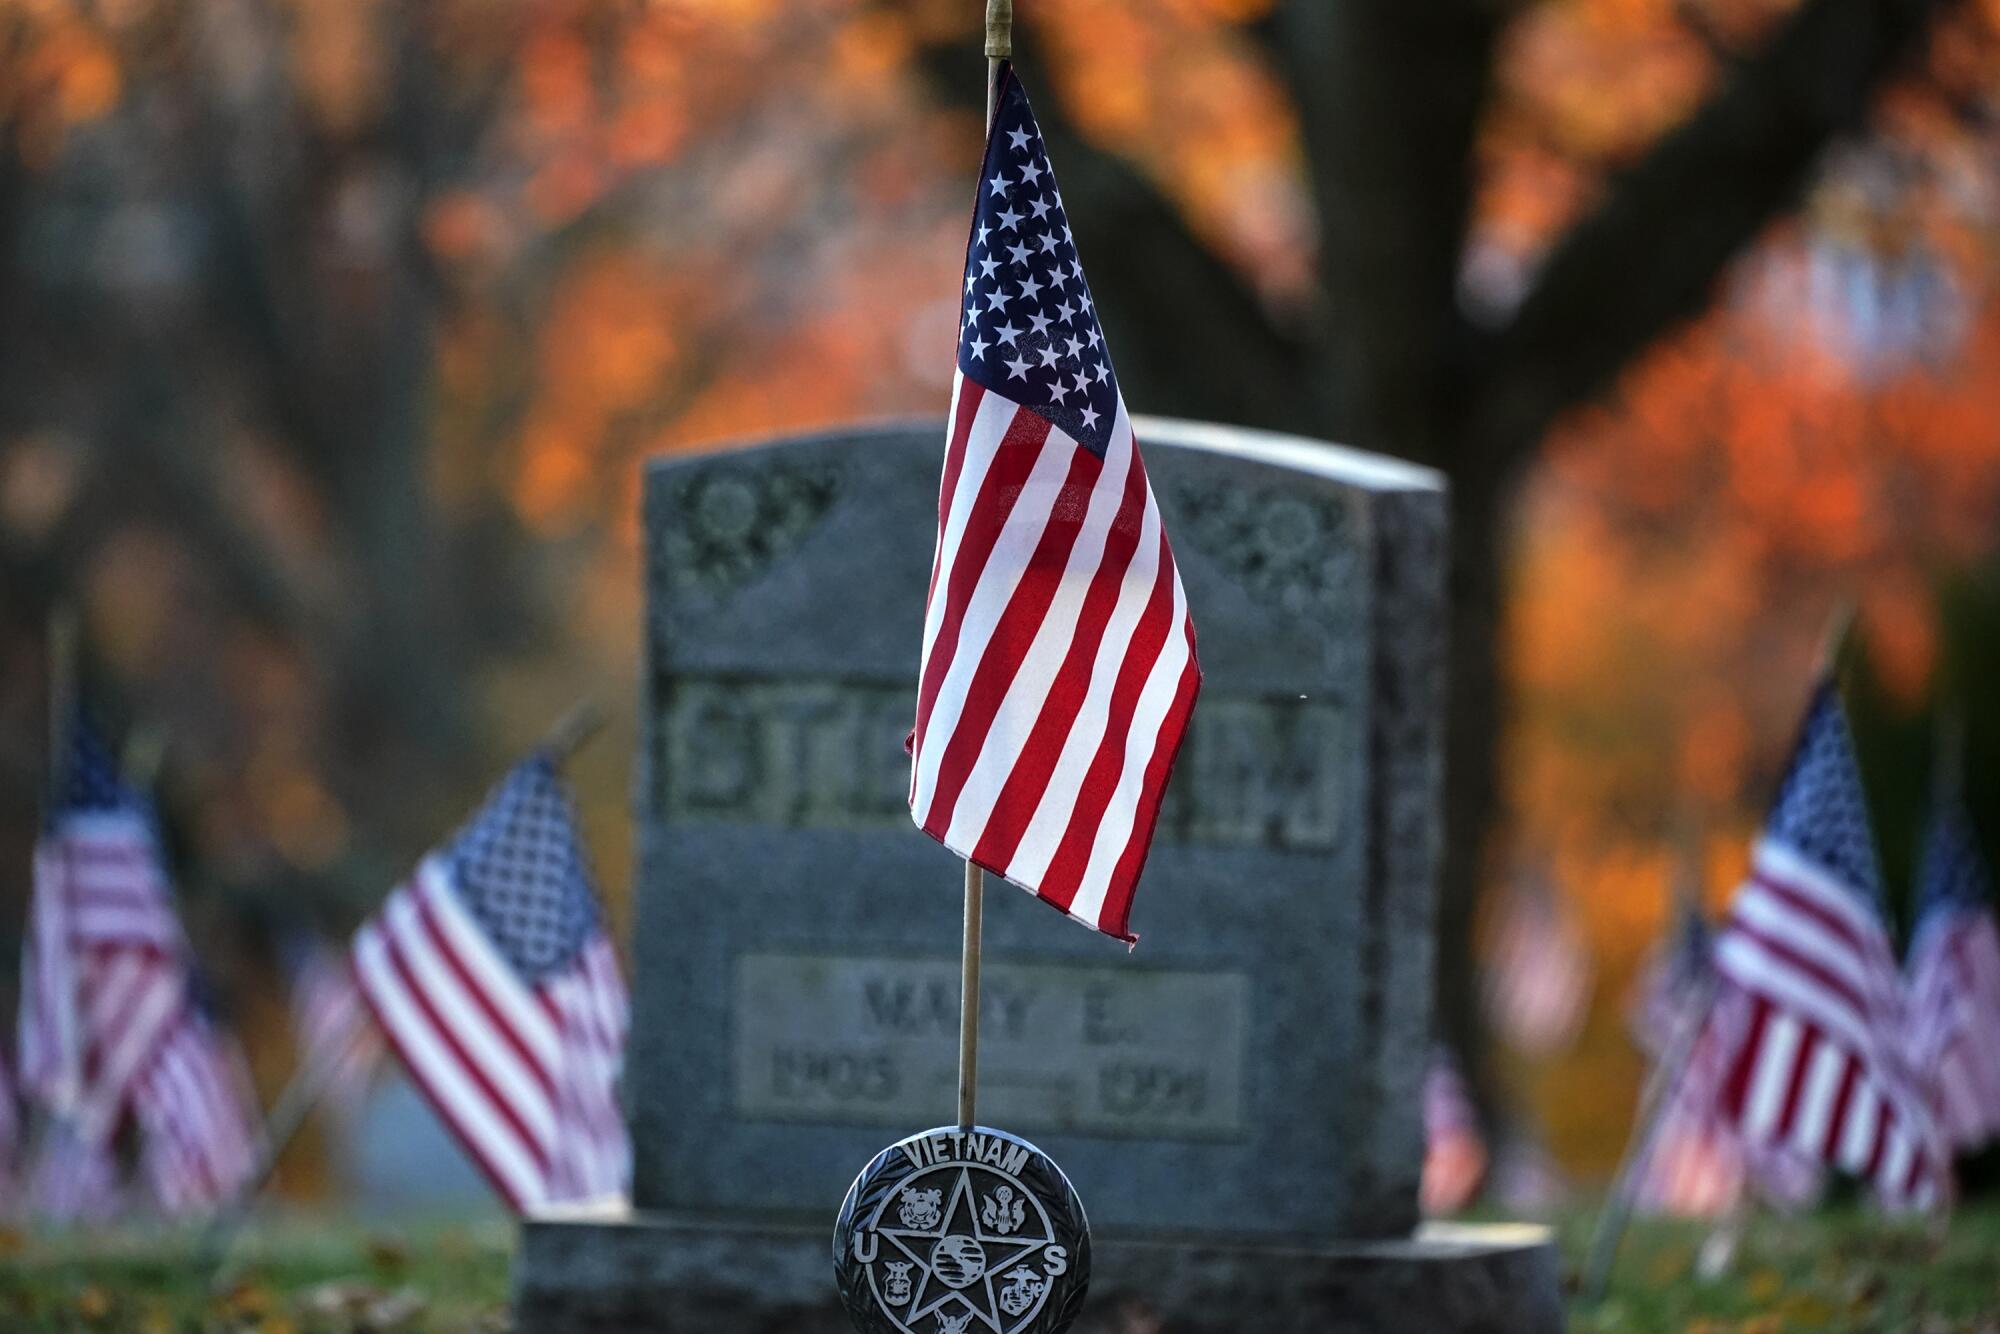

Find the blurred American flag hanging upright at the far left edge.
xmin=20 ymin=710 xmax=188 ymax=1146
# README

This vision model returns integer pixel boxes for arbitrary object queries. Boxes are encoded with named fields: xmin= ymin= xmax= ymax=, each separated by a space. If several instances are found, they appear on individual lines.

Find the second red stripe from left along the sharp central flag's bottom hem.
xmin=972 ymin=450 xmax=1146 ymax=868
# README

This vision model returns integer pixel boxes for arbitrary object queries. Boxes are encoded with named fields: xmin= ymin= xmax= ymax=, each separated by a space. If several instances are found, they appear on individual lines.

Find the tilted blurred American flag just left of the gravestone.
xmin=354 ymin=754 xmax=630 ymax=1212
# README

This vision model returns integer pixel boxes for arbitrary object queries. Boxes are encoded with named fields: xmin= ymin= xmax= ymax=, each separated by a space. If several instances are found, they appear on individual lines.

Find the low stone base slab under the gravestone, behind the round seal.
xmin=514 ymin=1210 xmax=1564 ymax=1334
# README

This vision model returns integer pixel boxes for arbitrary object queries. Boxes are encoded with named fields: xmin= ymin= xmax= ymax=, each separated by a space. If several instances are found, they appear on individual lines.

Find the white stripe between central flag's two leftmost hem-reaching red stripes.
xmin=944 ymin=412 xmax=1138 ymax=848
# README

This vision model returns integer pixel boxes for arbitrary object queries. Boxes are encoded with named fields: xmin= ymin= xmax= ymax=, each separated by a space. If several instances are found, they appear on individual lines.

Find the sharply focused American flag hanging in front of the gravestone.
xmin=910 ymin=66 xmax=1200 ymax=942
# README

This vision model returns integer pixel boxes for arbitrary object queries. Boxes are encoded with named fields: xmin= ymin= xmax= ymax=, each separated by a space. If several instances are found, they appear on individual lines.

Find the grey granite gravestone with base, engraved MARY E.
xmin=516 ymin=420 xmax=1560 ymax=1334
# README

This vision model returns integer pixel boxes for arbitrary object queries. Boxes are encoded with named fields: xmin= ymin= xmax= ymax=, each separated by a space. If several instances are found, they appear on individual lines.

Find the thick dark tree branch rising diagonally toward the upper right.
xmin=1468 ymin=0 xmax=1950 ymax=476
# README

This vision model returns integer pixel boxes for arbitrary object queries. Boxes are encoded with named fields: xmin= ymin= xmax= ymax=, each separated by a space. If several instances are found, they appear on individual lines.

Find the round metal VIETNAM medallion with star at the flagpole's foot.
xmin=834 ymin=1126 xmax=1090 ymax=1334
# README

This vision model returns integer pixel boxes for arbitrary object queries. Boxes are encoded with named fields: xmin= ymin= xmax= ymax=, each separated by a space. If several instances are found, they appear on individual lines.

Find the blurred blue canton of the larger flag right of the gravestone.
xmin=1764 ymin=678 xmax=1882 ymax=906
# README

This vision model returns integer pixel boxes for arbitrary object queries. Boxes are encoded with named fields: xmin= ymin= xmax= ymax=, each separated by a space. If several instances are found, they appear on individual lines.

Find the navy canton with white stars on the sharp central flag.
xmin=958 ymin=68 xmax=1118 ymax=458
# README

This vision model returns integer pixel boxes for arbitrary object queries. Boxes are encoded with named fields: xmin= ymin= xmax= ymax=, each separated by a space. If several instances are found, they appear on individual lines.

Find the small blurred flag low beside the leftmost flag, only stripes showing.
xmin=132 ymin=1000 xmax=260 ymax=1218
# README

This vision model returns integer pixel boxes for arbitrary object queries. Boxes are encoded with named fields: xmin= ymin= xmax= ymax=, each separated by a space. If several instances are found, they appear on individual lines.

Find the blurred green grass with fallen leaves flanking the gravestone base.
xmin=0 ymin=1202 xmax=2000 ymax=1334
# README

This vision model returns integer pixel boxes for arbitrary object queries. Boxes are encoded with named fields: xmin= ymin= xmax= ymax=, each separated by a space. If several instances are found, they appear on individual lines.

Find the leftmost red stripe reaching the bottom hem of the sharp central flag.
xmin=924 ymin=450 xmax=1104 ymax=838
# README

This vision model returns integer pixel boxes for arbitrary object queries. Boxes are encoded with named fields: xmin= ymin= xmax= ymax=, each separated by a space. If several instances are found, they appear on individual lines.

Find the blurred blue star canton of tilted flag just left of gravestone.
xmin=446 ymin=754 xmax=598 ymax=986
